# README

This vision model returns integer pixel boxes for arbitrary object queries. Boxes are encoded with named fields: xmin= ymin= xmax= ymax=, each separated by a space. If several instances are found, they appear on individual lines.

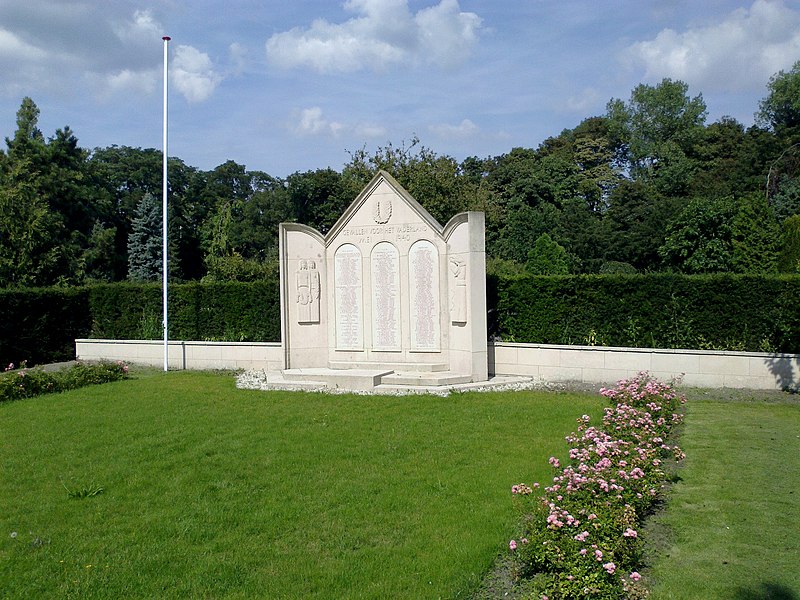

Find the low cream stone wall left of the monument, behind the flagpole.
xmin=75 ymin=339 xmax=283 ymax=370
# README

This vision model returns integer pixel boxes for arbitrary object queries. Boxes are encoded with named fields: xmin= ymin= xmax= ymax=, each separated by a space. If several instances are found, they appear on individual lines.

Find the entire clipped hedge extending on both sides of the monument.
xmin=0 ymin=274 xmax=800 ymax=364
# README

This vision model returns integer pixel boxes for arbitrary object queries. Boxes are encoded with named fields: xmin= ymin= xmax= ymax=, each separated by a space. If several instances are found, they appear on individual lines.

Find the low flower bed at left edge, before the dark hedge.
xmin=0 ymin=361 xmax=128 ymax=402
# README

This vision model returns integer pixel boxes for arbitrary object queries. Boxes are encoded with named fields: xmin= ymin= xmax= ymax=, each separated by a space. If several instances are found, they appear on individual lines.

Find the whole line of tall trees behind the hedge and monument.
xmin=0 ymin=61 xmax=800 ymax=287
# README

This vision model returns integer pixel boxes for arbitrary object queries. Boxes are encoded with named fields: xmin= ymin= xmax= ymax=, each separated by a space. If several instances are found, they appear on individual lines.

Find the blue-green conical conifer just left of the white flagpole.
xmin=128 ymin=192 xmax=163 ymax=281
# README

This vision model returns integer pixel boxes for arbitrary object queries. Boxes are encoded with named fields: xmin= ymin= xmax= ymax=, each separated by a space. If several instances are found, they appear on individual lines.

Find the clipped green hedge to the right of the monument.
xmin=488 ymin=274 xmax=800 ymax=353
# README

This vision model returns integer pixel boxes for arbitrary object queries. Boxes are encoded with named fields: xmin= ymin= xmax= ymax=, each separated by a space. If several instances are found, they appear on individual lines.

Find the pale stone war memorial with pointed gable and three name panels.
xmin=280 ymin=171 xmax=488 ymax=388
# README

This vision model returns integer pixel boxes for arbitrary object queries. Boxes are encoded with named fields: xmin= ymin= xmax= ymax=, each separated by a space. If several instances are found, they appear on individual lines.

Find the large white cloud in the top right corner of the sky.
xmin=625 ymin=0 xmax=800 ymax=91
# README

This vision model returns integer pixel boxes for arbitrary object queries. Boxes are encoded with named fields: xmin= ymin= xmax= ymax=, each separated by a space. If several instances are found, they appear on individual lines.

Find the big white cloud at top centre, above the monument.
xmin=266 ymin=0 xmax=481 ymax=73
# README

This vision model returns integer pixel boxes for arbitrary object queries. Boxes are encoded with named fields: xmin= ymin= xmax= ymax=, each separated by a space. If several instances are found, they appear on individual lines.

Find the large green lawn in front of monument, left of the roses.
xmin=0 ymin=372 xmax=604 ymax=598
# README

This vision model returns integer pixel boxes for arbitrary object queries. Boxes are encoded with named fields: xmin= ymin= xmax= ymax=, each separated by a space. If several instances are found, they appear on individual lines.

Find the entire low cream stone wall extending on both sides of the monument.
xmin=75 ymin=339 xmax=800 ymax=389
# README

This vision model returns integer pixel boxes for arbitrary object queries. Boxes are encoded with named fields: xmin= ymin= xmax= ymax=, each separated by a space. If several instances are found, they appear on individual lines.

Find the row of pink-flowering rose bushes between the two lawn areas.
xmin=512 ymin=373 xmax=686 ymax=599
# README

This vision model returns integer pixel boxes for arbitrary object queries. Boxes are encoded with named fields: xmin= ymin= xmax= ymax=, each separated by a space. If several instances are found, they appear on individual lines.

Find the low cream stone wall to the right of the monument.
xmin=489 ymin=342 xmax=800 ymax=389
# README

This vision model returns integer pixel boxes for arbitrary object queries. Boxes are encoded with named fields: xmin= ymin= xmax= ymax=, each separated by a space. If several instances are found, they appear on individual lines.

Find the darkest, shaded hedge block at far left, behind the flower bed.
xmin=0 ymin=288 xmax=92 ymax=365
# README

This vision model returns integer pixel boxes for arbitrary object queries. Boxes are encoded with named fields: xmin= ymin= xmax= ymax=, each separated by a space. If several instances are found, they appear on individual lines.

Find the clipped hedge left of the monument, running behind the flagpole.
xmin=0 ymin=278 xmax=280 ymax=365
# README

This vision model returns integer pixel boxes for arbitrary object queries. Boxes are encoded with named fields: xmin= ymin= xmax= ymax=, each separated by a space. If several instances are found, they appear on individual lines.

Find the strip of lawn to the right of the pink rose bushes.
xmin=649 ymin=395 xmax=800 ymax=600
